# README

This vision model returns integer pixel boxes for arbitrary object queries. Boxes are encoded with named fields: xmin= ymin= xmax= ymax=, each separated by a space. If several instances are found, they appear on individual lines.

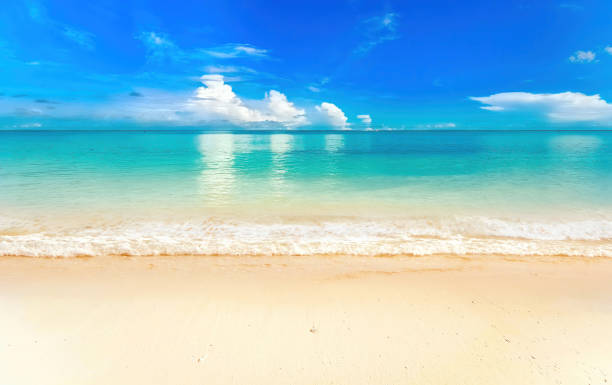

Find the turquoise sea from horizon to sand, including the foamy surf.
xmin=0 ymin=131 xmax=612 ymax=256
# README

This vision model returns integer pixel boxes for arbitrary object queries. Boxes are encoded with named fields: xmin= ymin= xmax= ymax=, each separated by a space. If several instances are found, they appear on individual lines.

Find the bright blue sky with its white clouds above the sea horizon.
xmin=0 ymin=0 xmax=612 ymax=130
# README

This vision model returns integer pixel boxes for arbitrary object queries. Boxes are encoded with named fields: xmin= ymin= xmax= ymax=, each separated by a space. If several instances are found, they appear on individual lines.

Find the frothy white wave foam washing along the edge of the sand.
xmin=0 ymin=217 xmax=612 ymax=257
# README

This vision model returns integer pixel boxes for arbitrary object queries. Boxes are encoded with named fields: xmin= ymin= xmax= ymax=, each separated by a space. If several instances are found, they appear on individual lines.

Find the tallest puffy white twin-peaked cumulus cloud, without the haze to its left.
xmin=187 ymin=74 xmax=308 ymax=128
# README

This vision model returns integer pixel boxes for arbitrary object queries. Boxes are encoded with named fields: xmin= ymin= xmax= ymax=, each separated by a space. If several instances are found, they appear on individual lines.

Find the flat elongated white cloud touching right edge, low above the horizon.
xmin=470 ymin=92 xmax=612 ymax=123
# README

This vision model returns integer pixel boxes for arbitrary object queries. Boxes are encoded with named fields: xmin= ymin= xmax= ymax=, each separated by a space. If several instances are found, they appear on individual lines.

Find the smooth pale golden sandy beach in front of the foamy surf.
xmin=0 ymin=257 xmax=612 ymax=385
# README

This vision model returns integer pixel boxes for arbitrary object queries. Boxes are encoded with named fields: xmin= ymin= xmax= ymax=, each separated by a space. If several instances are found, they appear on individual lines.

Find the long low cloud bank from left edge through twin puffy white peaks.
xmin=0 ymin=74 xmax=310 ymax=129
